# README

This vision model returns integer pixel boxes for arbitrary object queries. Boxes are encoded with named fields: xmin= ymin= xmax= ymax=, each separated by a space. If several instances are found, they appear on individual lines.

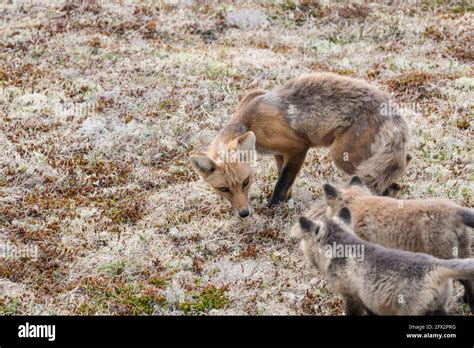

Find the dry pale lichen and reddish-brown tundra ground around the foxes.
xmin=0 ymin=0 xmax=474 ymax=315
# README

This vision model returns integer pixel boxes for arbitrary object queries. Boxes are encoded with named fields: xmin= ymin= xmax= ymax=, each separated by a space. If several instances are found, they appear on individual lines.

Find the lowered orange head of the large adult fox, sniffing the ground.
xmin=190 ymin=132 xmax=255 ymax=217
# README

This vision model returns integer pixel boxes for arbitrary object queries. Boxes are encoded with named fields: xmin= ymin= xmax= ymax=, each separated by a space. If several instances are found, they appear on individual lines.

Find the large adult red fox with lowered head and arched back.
xmin=190 ymin=73 xmax=409 ymax=217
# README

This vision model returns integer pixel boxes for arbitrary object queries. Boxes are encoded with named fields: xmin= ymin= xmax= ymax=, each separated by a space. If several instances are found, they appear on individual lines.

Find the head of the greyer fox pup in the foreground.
xmin=296 ymin=208 xmax=353 ymax=271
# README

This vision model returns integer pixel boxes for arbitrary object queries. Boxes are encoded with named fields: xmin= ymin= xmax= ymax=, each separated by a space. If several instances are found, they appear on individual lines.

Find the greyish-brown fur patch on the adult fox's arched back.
xmin=262 ymin=73 xmax=390 ymax=138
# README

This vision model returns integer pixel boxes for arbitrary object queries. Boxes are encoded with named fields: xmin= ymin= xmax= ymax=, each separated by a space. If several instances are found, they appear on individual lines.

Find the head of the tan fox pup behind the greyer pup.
xmin=323 ymin=176 xmax=371 ymax=215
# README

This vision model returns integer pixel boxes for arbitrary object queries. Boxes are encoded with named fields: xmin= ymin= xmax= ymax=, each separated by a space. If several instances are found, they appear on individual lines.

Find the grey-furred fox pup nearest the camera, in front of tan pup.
xmin=294 ymin=208 xmax=474 ymax=315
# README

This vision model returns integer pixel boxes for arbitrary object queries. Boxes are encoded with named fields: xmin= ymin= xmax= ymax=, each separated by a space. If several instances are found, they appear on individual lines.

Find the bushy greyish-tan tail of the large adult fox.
xmin=356 ymin=115 xmax=410 ymax=195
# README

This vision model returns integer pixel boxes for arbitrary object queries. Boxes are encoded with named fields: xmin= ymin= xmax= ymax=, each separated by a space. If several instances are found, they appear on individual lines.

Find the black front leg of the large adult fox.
xmin=267 ymin=150 xmax=307 ymax=208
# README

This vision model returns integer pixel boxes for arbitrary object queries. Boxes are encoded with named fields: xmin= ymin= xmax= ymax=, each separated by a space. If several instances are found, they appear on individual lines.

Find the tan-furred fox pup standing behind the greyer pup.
xmin=295 ymin=176 xmax=474 ymax=312
